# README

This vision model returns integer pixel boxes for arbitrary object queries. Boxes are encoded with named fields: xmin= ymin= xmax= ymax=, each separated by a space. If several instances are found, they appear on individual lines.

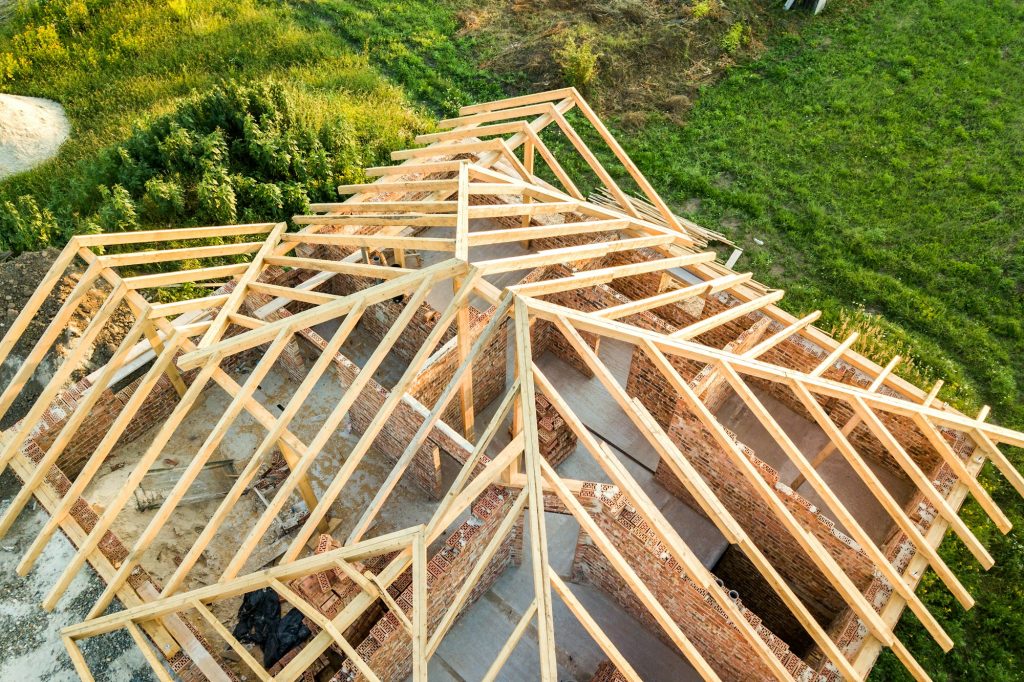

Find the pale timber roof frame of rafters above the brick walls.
xmin=0 ymin=88 xmax=1024 ymax=680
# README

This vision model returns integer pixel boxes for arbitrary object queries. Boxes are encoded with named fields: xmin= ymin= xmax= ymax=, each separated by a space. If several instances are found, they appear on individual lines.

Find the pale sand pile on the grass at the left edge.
xmin=0 ymin=94 xmax=71 ymax=178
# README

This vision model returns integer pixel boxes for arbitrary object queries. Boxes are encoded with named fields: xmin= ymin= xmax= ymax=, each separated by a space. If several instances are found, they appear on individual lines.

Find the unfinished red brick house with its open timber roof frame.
xmin=0 ymin=89 xmax=1024 ymax=681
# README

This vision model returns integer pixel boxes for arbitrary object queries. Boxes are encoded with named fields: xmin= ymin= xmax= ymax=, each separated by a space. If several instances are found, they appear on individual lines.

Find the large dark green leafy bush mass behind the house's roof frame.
xmin=68 ymin=77 xmax=361 ymax=237
